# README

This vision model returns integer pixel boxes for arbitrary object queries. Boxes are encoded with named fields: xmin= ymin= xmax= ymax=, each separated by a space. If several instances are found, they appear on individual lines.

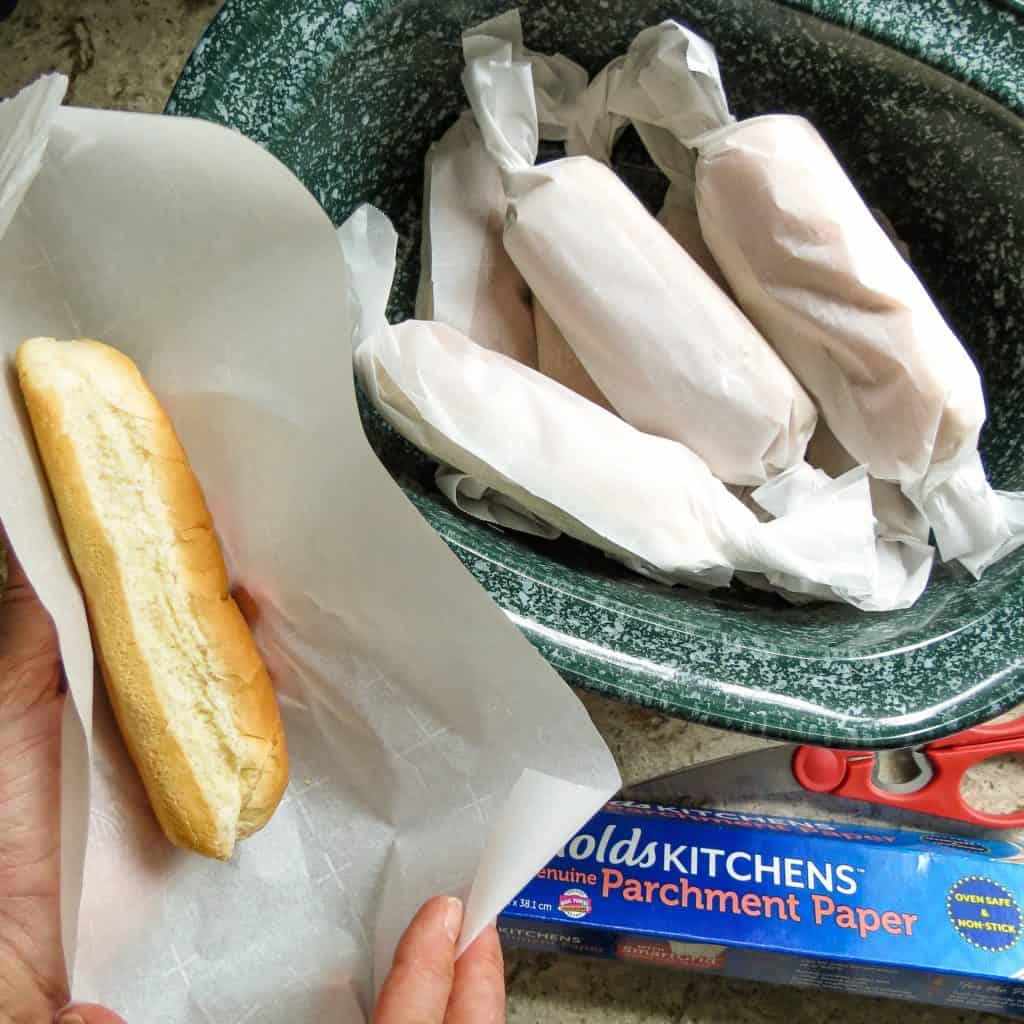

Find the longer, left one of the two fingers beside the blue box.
xmin=372 ymin=896 xmax=462 ymax=1024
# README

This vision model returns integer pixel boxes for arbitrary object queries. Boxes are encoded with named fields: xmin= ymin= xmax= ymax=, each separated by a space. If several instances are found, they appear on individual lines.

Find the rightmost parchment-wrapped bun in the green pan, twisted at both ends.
xmin=611 ymin=22 xmax=1024 ymax=575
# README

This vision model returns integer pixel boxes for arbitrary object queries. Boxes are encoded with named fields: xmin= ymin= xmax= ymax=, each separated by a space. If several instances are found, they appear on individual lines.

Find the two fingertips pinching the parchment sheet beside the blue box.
xmin=371 ymin=896 xmax=505 ymax=1024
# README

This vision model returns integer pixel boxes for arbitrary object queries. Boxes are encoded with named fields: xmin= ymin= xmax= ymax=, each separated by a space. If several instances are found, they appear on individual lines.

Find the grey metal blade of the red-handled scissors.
xmin=622 ymin=743 xmax=801 ymax=804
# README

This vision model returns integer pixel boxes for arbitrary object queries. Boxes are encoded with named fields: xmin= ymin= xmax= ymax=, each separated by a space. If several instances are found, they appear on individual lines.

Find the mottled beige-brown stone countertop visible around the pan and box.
xmin=0 ymin=0 xmax=1024 ymax=1024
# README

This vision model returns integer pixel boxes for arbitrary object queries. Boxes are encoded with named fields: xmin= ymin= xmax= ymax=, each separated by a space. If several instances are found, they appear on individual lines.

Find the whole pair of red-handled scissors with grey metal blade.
xmin=623 ymin=716 xmax=1024 ymax=828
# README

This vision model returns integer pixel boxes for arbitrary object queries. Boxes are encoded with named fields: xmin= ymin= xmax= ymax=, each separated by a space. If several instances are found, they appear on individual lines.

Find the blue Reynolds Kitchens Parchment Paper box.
xmin=499 ymin=802 xmax=1024 ymax=1017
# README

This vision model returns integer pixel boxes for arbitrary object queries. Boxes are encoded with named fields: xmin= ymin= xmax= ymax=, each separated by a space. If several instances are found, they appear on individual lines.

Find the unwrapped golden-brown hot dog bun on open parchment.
xmin=15 ymin=338 xmax=288 ymax=859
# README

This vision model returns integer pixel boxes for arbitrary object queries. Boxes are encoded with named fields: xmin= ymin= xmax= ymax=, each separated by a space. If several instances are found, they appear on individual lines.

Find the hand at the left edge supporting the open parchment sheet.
xmin=0 ymin=527 xmax=123 ymax=1024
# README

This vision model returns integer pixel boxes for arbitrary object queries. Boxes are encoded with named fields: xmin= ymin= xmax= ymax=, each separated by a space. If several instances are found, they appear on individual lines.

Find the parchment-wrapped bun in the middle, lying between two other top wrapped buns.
xmin=463 ymin=37 xmax=816 ymax=485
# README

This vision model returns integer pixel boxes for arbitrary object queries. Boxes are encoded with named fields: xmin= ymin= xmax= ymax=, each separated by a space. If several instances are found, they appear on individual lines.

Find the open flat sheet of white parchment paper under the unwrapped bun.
xmin=0 ymin=77 xmax=618 ymax=1024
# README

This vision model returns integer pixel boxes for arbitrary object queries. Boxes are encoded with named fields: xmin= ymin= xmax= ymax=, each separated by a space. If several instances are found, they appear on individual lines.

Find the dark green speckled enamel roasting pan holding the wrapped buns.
xmin=168 ymin=0 xmax=1024 ymax=748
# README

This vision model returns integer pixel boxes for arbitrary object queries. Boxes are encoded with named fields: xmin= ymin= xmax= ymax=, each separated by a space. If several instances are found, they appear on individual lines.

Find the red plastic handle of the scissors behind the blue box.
xmin=793 ymin=741 xmax=1024 ymax=828
